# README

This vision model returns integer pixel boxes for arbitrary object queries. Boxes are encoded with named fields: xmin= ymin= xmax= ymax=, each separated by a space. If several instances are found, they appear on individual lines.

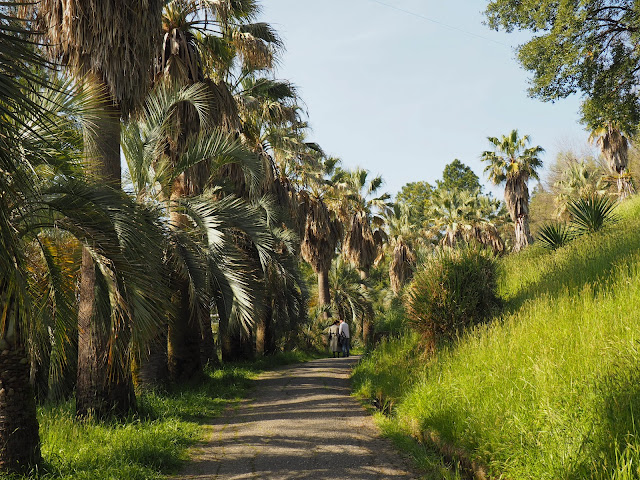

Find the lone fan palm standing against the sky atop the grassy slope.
xmin=481 ymin=130 xmax=544 ymax=252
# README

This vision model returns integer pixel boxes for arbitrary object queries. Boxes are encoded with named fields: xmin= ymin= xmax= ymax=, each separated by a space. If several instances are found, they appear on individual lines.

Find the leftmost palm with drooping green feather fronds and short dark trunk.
xmin=0 ymin=57 xmax=168 ymax=471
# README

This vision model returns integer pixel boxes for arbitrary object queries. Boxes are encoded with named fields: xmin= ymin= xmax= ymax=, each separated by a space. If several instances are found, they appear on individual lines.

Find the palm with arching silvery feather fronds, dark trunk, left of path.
xmin=123 ymin=84 xmax=274 ymax=380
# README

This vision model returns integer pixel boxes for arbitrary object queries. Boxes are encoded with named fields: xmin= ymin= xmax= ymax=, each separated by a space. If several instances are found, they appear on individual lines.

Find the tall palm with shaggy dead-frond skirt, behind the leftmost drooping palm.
xmin=35 ymin=0 xmax=164 ymax=416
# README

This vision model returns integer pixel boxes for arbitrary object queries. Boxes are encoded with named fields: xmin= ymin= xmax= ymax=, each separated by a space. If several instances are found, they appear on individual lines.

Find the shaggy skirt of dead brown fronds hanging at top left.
xmin=34 ymin=0 xmax=164 ymax=116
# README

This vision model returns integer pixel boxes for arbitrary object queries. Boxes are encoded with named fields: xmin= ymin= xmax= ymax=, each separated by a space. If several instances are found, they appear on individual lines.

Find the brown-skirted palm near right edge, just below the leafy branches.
xmin=589 ymin=122 xmax=634 ymax=200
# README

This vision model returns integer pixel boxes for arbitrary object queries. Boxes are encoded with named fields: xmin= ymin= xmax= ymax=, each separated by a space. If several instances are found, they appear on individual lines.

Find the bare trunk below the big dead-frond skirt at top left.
xmin=76 ymin=74 xmax=135 ymax=417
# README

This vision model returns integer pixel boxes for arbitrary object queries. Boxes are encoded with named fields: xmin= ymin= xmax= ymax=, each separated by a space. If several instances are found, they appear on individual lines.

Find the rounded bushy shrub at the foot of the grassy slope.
xmin=405 ymin=247 xmax=500 ymax=350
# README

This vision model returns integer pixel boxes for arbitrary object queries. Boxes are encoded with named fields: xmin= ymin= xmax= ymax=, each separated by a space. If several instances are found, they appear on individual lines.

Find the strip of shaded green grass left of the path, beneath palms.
xmin=5 ymin=352 xmax=311 ymax=480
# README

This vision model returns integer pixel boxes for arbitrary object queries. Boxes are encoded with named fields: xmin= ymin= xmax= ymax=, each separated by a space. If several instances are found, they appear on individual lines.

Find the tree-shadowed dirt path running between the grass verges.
xmin=176 ymin=357 xmax=420 ymax=480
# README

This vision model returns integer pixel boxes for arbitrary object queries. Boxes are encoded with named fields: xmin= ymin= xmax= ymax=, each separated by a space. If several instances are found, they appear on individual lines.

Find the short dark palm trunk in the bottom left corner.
xmin=0 ymin=340 xmax=41 ymax=472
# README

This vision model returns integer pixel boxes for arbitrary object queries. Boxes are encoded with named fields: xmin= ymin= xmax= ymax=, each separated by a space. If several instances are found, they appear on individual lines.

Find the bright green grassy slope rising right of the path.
xmin=355 ymin=193 xmax=640 ymax=479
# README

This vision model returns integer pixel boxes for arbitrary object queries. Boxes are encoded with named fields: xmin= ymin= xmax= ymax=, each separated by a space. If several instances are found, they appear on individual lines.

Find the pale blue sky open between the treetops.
xmin=262 ymin=0 xmax=588 ymax=198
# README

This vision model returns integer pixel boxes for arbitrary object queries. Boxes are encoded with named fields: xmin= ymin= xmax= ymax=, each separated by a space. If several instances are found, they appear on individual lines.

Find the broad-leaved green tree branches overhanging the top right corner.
xmin=485 ymin=0 xmax=640 ymax=127
